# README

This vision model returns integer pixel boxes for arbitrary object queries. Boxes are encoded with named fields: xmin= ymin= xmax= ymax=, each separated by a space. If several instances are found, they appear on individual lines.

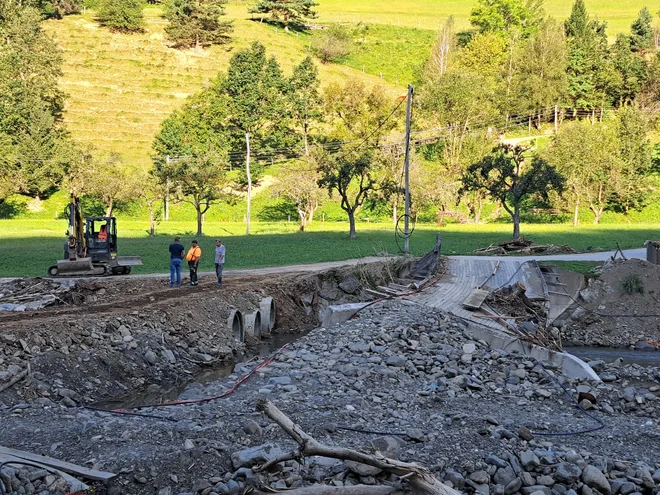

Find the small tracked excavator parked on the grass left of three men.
xmin=48 ymin=194 xmax=142 ymax=277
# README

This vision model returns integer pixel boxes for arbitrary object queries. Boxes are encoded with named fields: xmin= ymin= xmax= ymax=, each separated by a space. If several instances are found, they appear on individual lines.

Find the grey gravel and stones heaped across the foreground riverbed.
xmin=0 ymin=301 xmax=660 ymax=495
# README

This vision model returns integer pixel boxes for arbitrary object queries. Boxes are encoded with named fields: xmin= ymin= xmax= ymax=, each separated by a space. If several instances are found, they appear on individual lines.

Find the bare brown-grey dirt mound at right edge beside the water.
xmin=562 ymin=259 xmax=660 ymax=349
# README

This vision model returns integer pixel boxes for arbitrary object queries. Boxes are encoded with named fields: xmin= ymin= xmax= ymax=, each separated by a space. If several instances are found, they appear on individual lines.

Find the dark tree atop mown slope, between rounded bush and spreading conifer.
xmin=165 ymin=0 xmax=233 ymax=49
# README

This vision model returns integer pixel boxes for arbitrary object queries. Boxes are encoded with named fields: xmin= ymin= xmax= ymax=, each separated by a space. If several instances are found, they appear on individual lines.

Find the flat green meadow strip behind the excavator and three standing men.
xmin=0 ymin=219 xmax=660 ymax=276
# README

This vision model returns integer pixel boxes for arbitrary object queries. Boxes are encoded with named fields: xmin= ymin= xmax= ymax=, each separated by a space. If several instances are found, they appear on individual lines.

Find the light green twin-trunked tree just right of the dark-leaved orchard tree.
xmin=542 ymin=121 xmax=621 ymax=226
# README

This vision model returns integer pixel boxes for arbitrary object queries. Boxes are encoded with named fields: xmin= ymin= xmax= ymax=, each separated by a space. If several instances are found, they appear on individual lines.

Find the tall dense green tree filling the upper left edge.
xmin=0 ymin=0 xmax=69 ymax=201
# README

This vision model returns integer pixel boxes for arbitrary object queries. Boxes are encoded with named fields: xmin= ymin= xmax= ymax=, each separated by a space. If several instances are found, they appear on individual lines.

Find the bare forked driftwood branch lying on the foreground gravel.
xmin=257 ymin=399 xmax=460 ymax=495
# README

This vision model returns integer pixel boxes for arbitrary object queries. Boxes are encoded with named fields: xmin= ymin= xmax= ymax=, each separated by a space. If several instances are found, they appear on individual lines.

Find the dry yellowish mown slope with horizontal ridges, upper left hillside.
xmin=46 ymin=4 xmax=403 ymax=166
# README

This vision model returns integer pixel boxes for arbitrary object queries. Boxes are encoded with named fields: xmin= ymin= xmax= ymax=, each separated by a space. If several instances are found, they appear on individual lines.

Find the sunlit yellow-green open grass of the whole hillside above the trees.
xmin=46 ymin=0 xmax=655 ymax=167
